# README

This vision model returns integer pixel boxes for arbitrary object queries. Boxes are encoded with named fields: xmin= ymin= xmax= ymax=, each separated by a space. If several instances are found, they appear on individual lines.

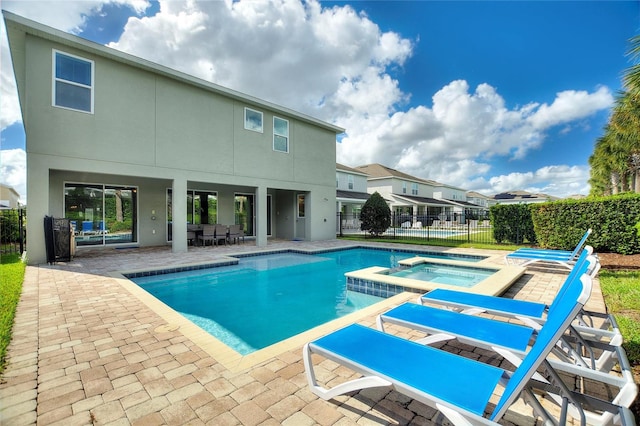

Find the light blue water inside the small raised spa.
xmin=389 ymin=262 xmax=496 ymax=288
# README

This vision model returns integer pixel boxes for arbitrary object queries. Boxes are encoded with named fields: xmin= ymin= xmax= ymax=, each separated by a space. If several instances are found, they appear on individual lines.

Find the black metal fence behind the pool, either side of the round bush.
xmin=336 ymin=213 xmax=496 ymax=244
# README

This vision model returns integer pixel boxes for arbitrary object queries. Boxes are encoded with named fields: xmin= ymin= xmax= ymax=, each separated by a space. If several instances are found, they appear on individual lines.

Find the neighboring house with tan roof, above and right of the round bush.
xmin=356 ymin=163 xmax=456 ymax=226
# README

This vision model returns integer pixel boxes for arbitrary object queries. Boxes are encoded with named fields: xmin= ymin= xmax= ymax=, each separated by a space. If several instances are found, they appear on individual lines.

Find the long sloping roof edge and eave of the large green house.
xmin=2 ymin=10 xmax=345 ymax=134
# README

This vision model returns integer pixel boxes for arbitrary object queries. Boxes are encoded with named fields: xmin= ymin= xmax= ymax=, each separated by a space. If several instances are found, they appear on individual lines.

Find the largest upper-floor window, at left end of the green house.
xmin=52 ymin=50 xmax=94 ymax=113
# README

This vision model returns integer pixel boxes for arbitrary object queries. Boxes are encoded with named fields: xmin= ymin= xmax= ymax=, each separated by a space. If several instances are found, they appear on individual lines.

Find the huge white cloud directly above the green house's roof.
xmin=110 ymin=0 xmax=412 ymax=121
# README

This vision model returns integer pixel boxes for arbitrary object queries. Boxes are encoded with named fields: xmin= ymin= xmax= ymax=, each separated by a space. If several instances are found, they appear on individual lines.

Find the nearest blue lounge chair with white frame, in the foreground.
xmin=303 ymin=264 xmax=633 ymax=425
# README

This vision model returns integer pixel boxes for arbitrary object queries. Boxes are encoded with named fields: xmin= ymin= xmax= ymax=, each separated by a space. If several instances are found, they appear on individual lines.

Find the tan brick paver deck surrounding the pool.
xmin=0 ymin=241 xmax=604 ymax=426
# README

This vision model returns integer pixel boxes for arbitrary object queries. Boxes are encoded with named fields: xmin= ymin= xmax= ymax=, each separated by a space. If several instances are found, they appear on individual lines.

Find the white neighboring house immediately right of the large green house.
xmin=336 ymin=163 xmax=370 ymax=229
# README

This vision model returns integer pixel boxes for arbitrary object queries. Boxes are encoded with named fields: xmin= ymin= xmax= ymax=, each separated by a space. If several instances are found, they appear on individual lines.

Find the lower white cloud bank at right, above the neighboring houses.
xmin=338 ymin=80 xmax=613 ymax=196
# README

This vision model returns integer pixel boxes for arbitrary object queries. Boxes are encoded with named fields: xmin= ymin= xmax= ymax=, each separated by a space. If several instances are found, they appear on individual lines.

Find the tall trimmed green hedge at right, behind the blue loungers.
xmin=528 ymin=194 xmax=640 ymax=254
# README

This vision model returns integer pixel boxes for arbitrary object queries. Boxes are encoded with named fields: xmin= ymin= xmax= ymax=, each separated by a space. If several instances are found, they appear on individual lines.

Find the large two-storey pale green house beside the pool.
xmin=3 ymin=11 xmax=344 ymax=263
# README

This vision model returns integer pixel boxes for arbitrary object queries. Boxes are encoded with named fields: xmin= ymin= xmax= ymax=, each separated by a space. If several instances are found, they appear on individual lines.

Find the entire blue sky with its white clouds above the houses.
xmin=0 ymin=0 xmax=640 ymax=203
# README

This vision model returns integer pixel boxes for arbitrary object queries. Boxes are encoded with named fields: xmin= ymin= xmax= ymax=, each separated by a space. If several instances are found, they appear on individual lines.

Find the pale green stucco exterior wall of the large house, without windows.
xmin=5 ymin=12 xmax=342 ymax=263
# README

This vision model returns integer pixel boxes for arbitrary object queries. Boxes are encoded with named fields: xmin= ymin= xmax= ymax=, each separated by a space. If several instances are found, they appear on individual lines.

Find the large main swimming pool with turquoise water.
xmin=129 ymin=248 xmax=490 ymax=355
